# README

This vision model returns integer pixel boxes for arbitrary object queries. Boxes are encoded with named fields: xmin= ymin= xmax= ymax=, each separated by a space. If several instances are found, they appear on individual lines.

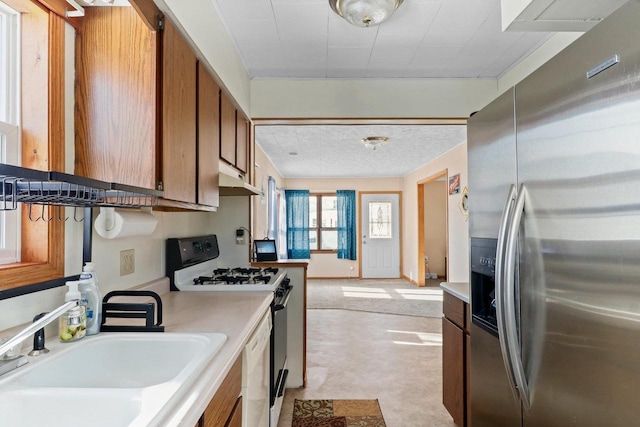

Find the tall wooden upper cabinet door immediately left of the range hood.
xmin=198 ymin=63 xmax=220 ymax=207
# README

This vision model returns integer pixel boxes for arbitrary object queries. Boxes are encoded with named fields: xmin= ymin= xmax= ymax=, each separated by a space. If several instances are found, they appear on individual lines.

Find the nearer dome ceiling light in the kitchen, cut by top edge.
xmin=329 ymin=0 xmax=403 ymax=27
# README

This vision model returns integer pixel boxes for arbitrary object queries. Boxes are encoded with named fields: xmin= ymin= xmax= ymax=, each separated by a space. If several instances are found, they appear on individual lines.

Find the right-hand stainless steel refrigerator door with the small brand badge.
xmin=516 ymin=0 xmax=640 ymax=427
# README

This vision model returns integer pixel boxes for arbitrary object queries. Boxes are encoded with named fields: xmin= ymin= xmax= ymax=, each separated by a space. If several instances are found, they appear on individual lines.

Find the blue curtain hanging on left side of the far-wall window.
xmin=284 ymin=190 xmax=311 ymax=259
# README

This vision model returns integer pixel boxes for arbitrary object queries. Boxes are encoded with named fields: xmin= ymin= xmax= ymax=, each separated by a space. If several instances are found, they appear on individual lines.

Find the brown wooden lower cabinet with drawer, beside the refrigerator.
xmin=442 ymin=292 xmax=471 ymax=427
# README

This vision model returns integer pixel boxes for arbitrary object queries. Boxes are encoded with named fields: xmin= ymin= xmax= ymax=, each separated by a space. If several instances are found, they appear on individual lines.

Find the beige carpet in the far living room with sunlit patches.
xmin=307 ymin=279 xmax=442 ymax=317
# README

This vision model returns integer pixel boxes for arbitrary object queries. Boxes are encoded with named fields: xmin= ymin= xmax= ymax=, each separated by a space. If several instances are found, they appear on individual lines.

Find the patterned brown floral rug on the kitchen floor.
xmin=291 ymin=399 xmax=386 ymax=427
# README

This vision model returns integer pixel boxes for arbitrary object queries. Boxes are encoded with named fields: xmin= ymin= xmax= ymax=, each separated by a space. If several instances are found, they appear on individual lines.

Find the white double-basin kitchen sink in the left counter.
xmin=0 ymin=333 xmax=227 ymax=427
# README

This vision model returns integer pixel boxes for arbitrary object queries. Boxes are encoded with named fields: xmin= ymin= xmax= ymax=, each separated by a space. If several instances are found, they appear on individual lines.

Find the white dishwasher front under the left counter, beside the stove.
xmin=242 ymin=310 xmax=271 ymax=427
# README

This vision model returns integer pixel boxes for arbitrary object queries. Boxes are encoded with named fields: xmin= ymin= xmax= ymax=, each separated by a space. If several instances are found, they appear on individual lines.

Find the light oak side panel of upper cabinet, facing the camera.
xmin=75 ymin=7 xmax=158 ymax=189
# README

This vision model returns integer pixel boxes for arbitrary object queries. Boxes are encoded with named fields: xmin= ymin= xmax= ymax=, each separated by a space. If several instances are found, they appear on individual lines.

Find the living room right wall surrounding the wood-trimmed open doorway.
xmin=402 ymin=143 xmax=469 ymax=282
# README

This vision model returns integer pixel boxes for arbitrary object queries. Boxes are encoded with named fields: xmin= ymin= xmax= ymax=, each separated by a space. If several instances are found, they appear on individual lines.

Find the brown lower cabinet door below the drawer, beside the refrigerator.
xmin=442 ymin=317 xmax=465 ymax=427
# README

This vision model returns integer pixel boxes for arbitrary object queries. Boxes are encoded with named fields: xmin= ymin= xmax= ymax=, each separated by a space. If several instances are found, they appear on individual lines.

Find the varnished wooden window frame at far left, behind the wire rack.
xmin=0 ymin=0 xmax=66 ymax=299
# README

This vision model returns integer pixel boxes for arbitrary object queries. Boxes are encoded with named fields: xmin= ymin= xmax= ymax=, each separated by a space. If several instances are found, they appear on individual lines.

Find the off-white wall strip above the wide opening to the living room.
xmin=251 ymin=79 xmax=498 ymax=118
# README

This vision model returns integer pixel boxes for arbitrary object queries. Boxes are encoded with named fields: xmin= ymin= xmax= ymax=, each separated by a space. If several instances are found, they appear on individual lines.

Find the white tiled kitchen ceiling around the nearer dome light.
xmin=211 ymin=0 xmax=550 ymax=78
